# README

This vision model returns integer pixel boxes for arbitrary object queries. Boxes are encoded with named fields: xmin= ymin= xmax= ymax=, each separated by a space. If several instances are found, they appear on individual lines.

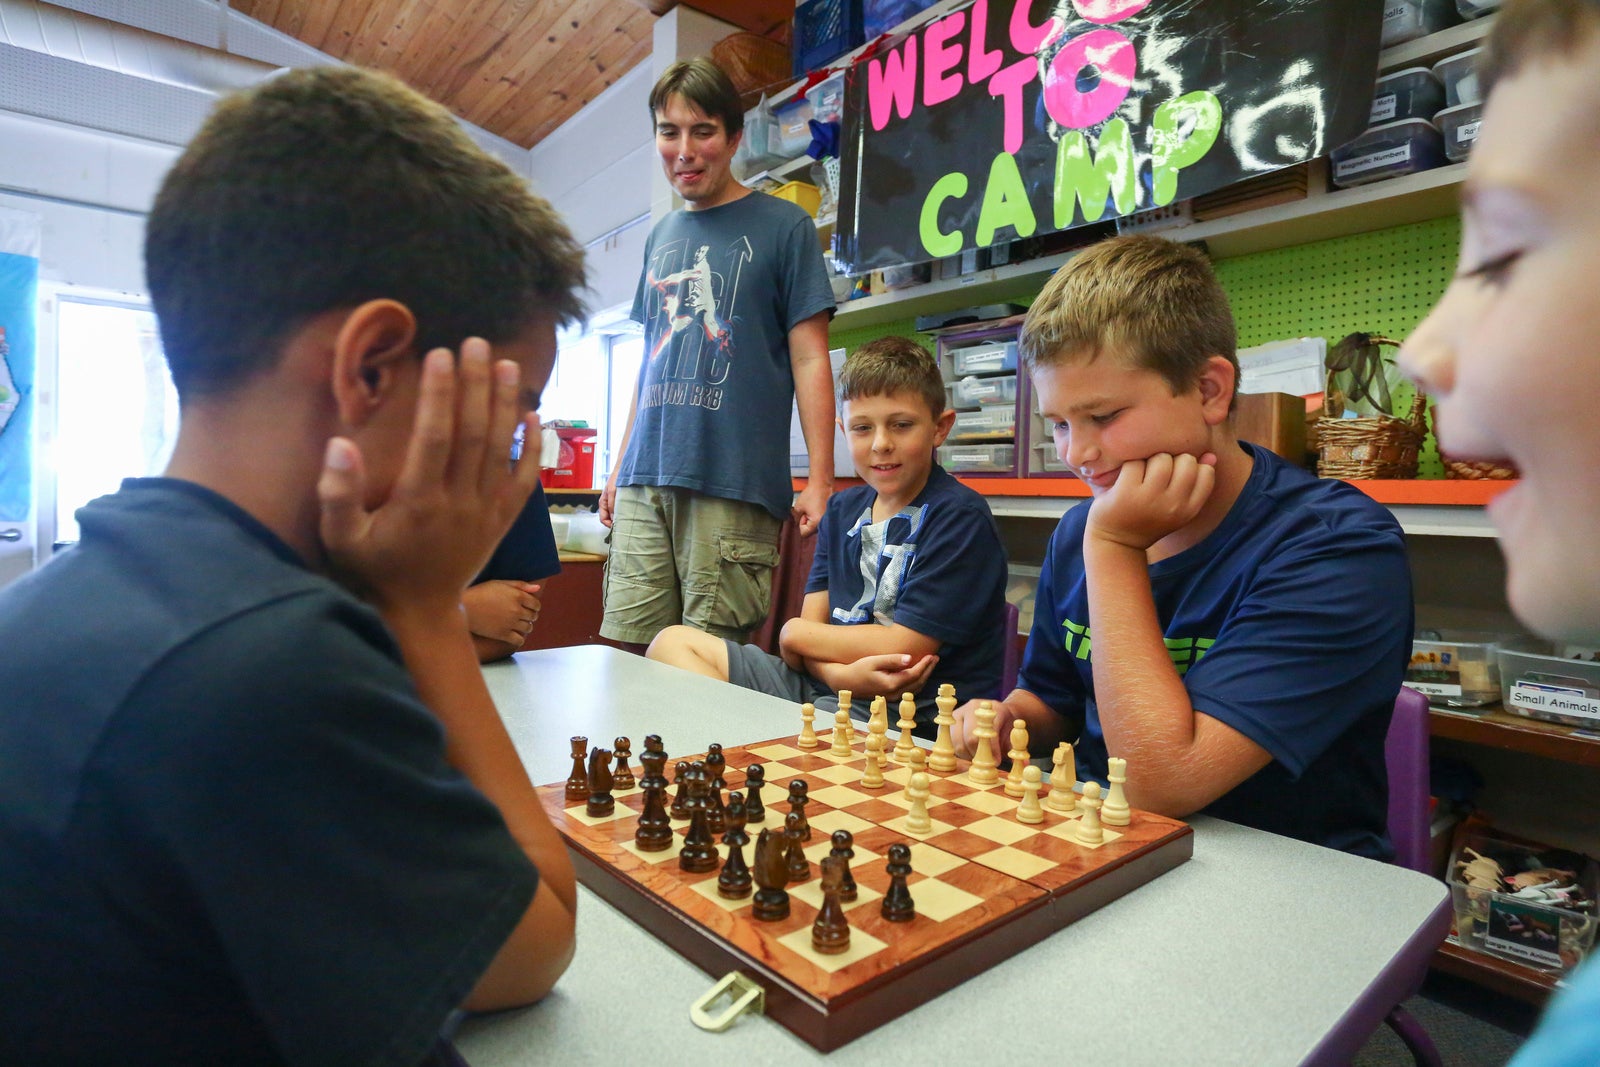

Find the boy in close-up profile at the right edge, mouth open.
xmin=1400 ymin=0 xmax=1600 ymax=1067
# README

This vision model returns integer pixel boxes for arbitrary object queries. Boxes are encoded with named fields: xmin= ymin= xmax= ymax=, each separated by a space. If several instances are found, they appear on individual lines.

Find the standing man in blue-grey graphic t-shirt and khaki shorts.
xmin=600 ymin=58 xmax=834 ymax=653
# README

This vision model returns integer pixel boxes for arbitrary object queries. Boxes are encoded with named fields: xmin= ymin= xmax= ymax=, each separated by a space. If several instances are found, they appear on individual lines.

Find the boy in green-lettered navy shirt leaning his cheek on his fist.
xmin=954 ymin=235 xmax=1411 ymax=857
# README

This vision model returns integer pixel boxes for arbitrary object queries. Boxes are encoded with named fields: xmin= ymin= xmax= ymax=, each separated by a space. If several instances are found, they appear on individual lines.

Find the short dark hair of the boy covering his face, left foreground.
xmin=144 ymin=67 xmax=584 ymax=397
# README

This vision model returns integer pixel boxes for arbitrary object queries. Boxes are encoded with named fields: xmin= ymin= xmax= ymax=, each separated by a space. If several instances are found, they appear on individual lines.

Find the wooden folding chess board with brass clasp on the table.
xmin=539 ymin=723 xmax=1194 ymax=1051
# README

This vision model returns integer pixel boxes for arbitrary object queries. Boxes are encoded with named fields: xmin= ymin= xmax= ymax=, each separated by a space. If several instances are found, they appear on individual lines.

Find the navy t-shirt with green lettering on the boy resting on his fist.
xmin=1018 ymin=445 xmax=1411 ymax=859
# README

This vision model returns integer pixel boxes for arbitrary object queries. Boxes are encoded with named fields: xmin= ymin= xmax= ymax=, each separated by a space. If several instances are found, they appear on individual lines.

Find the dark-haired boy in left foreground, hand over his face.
xmin=0 ymin=67 xmax=582 ymax=1065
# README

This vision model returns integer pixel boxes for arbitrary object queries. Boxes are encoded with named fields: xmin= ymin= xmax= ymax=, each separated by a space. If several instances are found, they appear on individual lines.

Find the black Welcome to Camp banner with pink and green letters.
xmin=835 ymin=0 xmax=1382 ymax=274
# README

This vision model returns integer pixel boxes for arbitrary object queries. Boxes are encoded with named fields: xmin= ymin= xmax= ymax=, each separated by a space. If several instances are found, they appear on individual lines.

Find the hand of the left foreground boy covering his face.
xmin=317 ymin=338 xmax=539 ymax=614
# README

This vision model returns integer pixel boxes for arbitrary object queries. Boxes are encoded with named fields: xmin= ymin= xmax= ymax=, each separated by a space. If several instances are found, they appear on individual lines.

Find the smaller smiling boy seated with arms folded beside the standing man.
xmin=650 ymin=338 xmax=1005 ymax=737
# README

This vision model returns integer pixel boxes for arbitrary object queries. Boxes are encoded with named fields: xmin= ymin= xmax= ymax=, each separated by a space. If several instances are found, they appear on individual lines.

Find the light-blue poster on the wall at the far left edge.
xmin=0 ymin=208 xmax=40 ymax=523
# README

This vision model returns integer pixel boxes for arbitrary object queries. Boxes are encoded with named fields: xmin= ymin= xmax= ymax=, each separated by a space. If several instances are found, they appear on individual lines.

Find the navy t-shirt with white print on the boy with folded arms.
xmin=805 ymin=464 xmax=1006 ymax=723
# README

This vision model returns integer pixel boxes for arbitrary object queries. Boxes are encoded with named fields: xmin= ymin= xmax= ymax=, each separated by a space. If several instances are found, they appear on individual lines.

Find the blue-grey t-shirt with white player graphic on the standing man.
xmin=618 ymin=192 xmax=834 ymax=518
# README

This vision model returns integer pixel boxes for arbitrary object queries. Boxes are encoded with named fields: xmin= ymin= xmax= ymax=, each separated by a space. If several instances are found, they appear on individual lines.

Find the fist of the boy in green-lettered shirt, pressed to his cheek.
xmin=1086 ymin=453 xmax=1216 ymax=552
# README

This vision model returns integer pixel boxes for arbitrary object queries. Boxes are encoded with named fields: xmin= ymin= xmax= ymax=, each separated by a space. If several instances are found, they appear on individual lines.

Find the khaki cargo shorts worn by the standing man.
xmin=600 ymin=485 xmax=782 ymax=645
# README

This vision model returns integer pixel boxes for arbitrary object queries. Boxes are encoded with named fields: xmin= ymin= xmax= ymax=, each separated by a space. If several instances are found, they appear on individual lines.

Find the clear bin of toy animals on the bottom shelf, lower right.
xmin=1448 ymin=833 xmax=1600 ymax=974
